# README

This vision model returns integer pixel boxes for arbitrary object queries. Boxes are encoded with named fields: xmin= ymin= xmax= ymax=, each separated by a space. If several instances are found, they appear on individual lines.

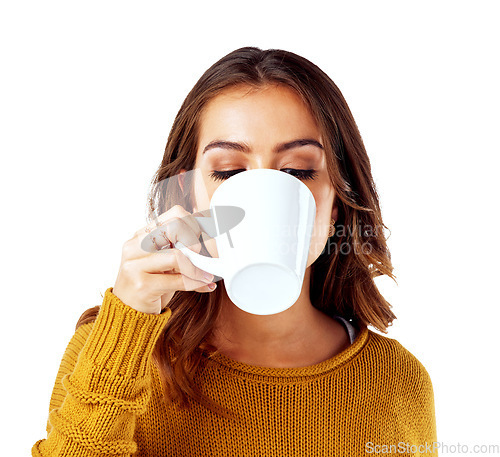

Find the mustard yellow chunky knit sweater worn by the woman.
xmin=32 ymin=288 xmax=437 ymax=457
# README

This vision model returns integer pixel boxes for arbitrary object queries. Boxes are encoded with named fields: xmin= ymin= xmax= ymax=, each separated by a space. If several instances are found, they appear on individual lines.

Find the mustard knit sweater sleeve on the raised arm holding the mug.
xmin=31 ymin=288 xmax=172 ymax=457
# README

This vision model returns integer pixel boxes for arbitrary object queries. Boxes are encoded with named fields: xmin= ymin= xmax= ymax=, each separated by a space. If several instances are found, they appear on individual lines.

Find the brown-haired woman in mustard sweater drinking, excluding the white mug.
xmin=32 ymin=47 xmax=436 ymax=456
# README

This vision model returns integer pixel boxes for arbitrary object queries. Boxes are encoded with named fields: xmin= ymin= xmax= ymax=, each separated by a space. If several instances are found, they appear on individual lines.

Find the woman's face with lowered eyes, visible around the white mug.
xmin=182 ymin=86 xmax=337 ymax=267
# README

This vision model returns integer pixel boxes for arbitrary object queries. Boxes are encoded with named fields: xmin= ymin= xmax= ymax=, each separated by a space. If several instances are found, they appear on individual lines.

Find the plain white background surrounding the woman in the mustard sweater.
xmin=0 ymin=0 xmax=500 ymax=456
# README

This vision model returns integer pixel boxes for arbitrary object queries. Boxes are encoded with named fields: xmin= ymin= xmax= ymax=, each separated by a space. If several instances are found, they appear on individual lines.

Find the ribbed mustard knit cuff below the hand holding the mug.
xmin=80 ymin=287 xmax=172 ymax=380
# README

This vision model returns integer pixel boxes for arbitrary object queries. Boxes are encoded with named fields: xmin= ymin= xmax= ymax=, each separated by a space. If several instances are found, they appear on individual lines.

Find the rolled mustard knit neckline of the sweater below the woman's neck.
xmin=205 ymin=327 xmax=370 ymax=381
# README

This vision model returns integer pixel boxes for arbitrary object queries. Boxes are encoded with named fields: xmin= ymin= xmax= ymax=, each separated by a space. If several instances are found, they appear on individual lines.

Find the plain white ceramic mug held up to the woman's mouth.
xmin=175 ymin=168 xmax=316 ymax=315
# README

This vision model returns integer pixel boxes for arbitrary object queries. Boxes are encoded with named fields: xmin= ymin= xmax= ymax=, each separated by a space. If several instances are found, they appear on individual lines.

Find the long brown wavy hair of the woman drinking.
xmin=77 ymin=47 xmax=397 ymax=417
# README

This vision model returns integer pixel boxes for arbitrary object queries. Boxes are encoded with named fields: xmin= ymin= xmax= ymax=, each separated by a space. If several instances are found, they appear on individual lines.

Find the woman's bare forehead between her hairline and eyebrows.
xmin=199 ymin=85 xmax=319 ymax=138
